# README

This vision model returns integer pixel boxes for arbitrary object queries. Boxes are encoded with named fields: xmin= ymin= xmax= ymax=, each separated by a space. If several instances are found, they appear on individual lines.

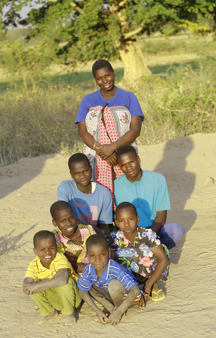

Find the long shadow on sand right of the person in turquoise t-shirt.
xmin=154 ymin=137 xmax=197 ymax=264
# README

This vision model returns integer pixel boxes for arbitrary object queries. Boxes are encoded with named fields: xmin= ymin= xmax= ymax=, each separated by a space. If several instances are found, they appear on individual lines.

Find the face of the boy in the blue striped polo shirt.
xmin=87 ymin=244 xmax=109 ymax=273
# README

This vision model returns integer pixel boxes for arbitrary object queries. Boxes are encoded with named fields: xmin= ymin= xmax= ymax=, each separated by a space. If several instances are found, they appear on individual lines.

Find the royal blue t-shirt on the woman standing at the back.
xmin=75 ymin=87 xmax=144 ymax=123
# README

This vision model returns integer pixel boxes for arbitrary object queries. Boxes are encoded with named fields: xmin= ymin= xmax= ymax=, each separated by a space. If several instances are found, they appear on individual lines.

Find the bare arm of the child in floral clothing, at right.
xmin=144 ymin=245 xmax=169 ymax=301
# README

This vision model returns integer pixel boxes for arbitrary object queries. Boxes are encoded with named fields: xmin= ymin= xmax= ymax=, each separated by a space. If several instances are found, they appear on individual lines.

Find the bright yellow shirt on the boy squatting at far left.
xmin=25 ymin=252 xmax=78 ymax=280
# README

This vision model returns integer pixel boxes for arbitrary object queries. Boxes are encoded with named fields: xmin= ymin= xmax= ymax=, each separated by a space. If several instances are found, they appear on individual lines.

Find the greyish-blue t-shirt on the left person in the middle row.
xmin=57 ymin=180 xmax=113 ymax=226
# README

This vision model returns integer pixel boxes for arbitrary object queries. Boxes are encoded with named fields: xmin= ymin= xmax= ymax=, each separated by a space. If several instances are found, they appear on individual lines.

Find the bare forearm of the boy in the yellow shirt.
xmin=23 ymin=269 xmax=69 ymax=295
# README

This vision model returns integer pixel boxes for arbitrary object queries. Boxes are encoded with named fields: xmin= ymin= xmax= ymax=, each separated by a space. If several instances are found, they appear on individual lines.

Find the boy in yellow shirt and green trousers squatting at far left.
xmin=23 ymin=230 xmax=81 ymax=325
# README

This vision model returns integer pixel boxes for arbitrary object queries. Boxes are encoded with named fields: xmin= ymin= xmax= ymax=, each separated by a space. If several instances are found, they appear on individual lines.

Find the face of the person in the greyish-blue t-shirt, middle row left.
xmin=70 ymin=161 xmax=92 ymax=190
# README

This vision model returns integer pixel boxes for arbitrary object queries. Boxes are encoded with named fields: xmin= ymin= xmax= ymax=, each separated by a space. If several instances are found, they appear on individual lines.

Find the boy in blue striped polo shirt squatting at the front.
xmin=77 ymin=234 xmax=141 ymax=325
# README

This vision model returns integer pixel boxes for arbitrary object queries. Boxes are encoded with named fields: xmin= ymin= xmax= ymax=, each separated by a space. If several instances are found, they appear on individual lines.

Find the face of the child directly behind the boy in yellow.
xmin=53 ymin=208 xmax=77 ymax=238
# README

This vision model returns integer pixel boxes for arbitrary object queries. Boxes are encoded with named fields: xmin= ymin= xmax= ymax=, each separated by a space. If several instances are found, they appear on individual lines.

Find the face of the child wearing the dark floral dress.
xmin=115 ymin=207 xmax=139 ymax=235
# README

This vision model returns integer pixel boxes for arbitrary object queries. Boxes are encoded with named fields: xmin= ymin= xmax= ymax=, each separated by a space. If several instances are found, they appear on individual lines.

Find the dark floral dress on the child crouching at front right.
xmin=114 ymin=226 xmax=169 ymax=282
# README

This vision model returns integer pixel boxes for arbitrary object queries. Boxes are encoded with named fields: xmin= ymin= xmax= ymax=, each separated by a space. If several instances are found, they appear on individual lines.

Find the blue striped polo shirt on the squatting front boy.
xmin=77 ymin=259 xmax=138 ymax=291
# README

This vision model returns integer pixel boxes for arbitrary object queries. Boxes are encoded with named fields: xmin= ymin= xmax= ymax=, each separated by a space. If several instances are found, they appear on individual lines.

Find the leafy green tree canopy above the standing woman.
xmin=0 ymin=0 xmax=216 ymax=80
